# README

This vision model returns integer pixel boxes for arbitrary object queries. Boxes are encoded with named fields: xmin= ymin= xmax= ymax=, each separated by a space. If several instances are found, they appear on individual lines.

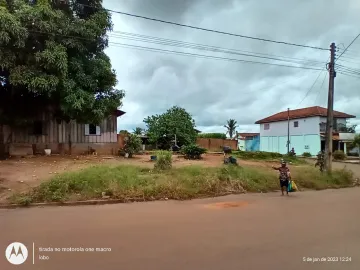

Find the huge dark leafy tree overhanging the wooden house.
xmin=0 ymin=0 xmax=124 ymax=157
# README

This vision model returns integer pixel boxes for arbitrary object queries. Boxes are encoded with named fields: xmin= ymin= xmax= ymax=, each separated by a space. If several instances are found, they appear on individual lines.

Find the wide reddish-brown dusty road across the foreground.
xmin=0 ymin=188 xmax=360 ymax=270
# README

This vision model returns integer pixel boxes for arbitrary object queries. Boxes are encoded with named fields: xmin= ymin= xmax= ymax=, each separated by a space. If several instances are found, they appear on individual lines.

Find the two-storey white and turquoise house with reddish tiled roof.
xmin=255 ymin=106 xmax=356 ymax=155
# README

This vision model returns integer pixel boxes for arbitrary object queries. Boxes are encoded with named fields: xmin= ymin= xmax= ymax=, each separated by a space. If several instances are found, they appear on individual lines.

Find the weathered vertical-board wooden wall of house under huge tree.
xmin=4 ymin=116 xmax=117 ymax=144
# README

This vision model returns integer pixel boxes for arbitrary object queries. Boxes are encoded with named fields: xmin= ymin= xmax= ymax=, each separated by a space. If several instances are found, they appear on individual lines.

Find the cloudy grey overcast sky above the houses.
xmin=104 ymin=0 xmax=360 ymax=132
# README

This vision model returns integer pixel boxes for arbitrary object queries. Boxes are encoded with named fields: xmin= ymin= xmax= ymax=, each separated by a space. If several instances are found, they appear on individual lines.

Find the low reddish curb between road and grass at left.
xmin=0 ymin=199 xmax=143 ymax=209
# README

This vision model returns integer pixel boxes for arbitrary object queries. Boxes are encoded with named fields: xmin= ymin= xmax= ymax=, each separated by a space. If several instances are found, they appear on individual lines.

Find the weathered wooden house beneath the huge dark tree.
xmin=4 ymin=110 xmax=125 ymax=156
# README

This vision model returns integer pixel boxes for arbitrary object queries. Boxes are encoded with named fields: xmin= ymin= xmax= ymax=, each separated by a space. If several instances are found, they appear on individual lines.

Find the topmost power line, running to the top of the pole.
xmin=82 ymin=4 xmax=329 ymax=51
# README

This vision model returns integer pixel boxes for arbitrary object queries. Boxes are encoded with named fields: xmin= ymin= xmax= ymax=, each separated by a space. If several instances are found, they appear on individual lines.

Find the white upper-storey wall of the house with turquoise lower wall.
xmin=260 ymin=116 xmax=320 ymax=137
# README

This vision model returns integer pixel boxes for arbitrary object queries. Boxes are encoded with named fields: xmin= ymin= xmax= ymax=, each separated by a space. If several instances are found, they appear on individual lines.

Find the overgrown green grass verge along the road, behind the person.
xmin=9 ymin=165 xmax=352 ymax=205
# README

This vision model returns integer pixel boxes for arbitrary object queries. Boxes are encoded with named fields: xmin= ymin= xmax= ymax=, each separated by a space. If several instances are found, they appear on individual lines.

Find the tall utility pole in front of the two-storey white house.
xmin=324 ymin=43 xmax=336 ymax=173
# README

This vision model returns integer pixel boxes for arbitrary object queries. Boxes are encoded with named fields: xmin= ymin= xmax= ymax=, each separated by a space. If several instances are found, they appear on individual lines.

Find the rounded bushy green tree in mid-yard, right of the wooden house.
xmin=144 ymin=106 xmax=197 ymax=149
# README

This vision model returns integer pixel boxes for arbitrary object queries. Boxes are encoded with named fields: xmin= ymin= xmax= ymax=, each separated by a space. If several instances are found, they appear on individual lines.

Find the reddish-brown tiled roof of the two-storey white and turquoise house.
xmin=255 ymin=106 xmax=356 ymax=124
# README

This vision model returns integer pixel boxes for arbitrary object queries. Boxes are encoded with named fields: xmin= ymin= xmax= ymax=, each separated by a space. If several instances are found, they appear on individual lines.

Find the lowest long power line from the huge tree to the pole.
xmin=25 ymin=31 xmax=321 ymax=70
